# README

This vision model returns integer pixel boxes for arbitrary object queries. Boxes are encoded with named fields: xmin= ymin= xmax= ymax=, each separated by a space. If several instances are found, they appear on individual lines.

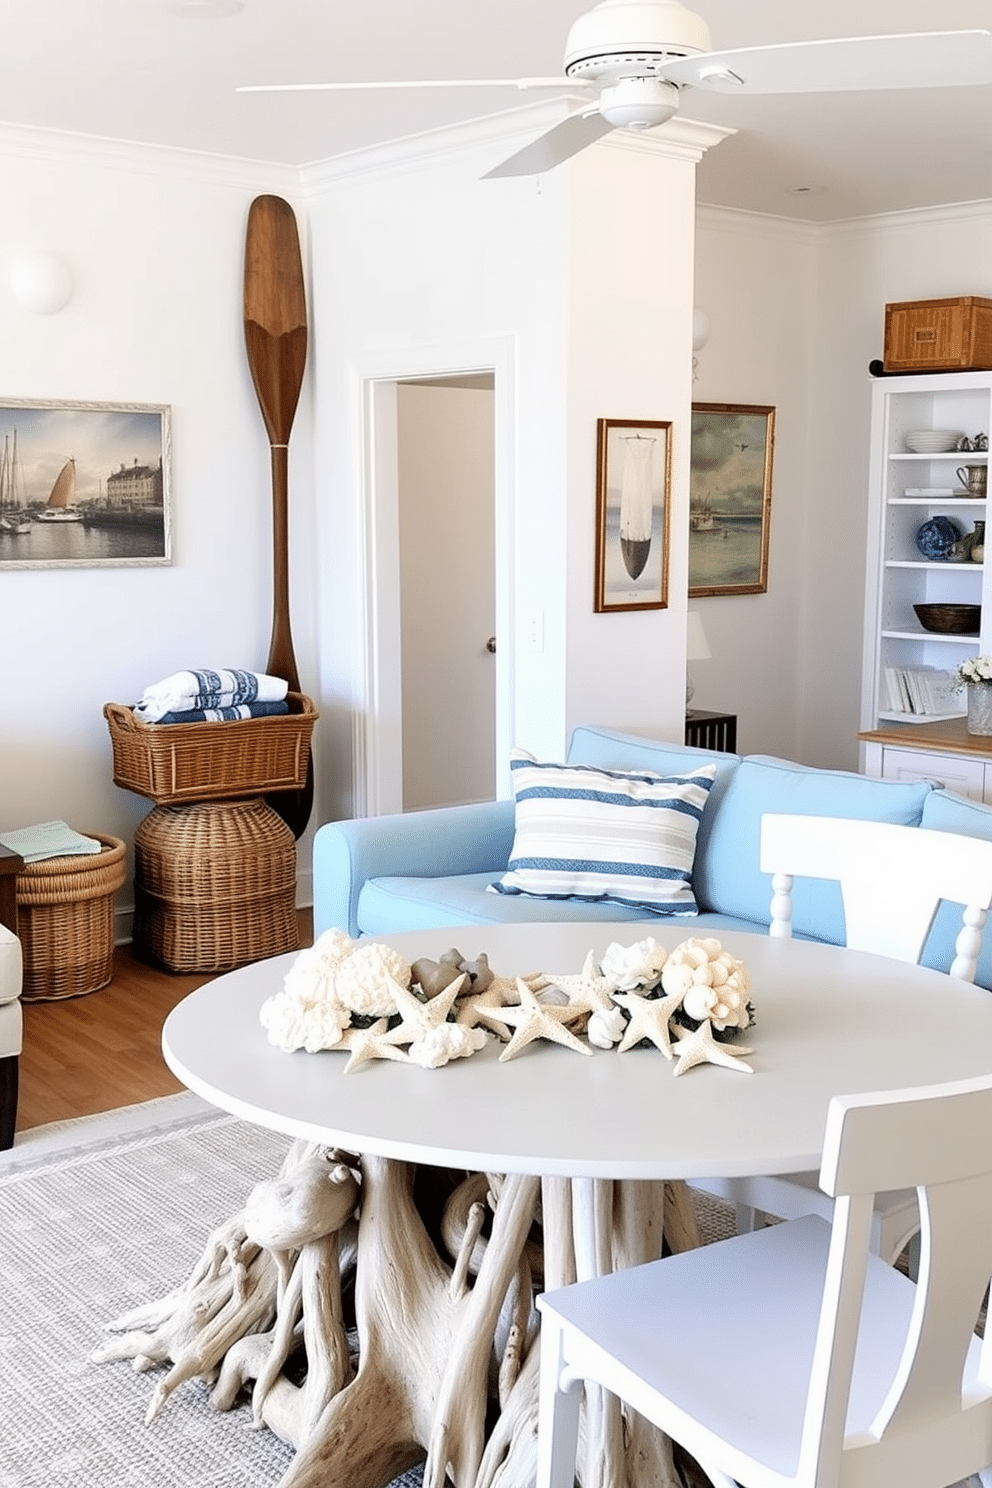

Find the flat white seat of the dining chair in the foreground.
xmin=538 ymin=1214 xmax=980 ymax=1482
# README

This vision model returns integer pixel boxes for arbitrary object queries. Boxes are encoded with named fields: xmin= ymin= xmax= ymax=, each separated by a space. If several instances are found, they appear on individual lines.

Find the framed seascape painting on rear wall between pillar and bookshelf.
xmin=689 ymin=403 xmax=775 ymax=600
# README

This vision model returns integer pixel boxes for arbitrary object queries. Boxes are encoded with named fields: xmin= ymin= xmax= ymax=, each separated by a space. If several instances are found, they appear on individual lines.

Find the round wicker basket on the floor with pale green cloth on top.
xmin=18 ymin=832 xmax=125 ymax=1001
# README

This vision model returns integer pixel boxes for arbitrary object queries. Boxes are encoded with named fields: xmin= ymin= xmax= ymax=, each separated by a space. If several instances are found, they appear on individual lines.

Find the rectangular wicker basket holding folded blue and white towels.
xmin=103 ymin=692 xmax=318 ymax=805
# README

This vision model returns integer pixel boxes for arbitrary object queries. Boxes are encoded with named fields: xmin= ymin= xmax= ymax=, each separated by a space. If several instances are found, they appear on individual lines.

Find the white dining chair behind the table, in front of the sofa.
xmin=696 ymin=814 xmax=992 ymax=1269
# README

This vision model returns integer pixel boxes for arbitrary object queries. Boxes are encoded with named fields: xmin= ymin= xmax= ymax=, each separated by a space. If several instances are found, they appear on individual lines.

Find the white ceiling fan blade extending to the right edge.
xmin=662 ymin=31 xmax=992 ymax=94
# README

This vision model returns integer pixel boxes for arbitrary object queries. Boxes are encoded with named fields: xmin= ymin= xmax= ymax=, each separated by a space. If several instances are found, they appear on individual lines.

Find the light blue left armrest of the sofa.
xmin=314 ymin=801 xmax=515 ymax=936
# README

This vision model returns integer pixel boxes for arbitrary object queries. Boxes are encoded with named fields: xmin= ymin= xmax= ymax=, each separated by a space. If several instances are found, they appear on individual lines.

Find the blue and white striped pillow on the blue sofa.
xmin=489 ymin=750 xmax=717 ymax=915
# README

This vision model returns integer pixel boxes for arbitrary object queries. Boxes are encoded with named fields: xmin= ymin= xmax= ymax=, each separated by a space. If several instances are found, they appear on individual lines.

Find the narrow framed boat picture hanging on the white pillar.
xmin=593 ymin=418 xmax=672 ymax=612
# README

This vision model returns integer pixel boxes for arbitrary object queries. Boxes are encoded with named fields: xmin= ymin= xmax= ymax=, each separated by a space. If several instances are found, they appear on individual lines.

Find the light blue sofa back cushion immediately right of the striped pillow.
xmin=695 ymin=754 xmax=933 ymax=945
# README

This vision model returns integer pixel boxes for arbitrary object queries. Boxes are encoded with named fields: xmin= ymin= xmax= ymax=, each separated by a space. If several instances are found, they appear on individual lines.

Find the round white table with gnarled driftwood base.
xmin=151 ymin=920 xmax=992 ymax=1488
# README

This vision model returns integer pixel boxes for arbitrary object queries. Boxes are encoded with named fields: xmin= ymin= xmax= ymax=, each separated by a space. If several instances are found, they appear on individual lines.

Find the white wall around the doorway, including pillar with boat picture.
xmin=308 ymin=113 xmax=713 ymax=815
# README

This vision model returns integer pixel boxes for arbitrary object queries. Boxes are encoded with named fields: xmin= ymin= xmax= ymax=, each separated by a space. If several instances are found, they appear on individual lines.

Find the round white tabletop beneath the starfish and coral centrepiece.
xmin=164 ymin=920 xmax=992 ymax=1178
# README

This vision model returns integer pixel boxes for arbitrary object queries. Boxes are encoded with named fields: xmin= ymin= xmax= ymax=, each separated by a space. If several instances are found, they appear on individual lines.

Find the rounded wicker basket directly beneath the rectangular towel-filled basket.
xmin=134 ymin=803 xmax=299 ymax=972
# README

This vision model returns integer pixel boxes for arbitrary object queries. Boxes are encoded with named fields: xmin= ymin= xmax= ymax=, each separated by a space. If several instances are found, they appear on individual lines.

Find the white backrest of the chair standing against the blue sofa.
xmin=761 ymin=814 xmax=992 ymax=982
